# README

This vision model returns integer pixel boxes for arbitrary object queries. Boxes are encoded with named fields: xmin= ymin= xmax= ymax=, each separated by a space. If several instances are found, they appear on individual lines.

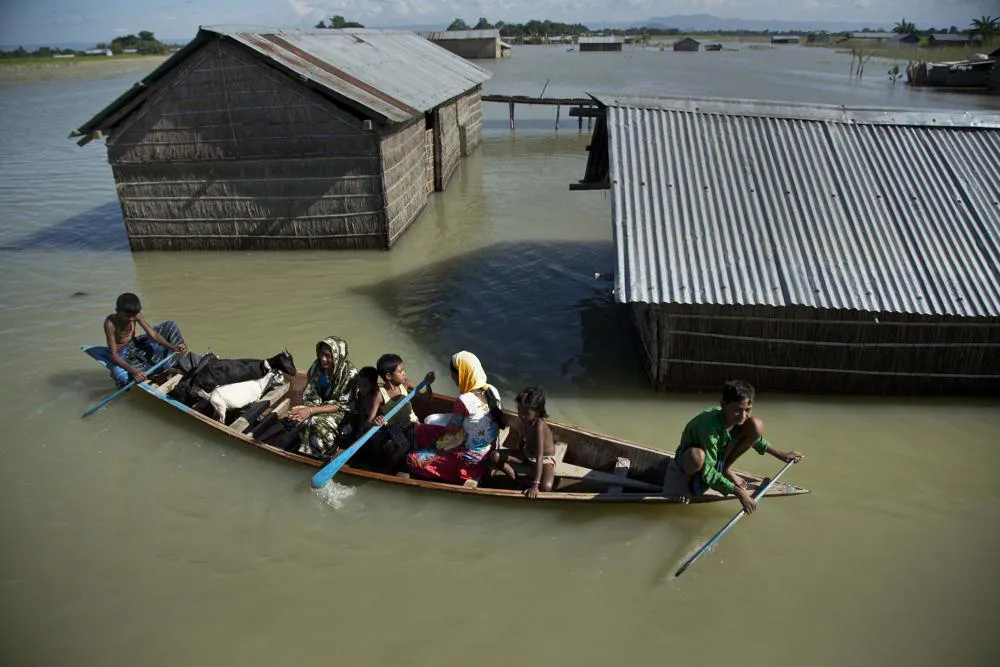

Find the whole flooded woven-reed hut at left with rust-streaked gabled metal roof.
xmin=73 ymin=27 xmax=490 ymax=250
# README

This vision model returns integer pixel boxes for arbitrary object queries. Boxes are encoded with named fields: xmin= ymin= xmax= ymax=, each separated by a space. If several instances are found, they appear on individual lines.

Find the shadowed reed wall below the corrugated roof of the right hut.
xmin=632 ymin=304 xmax=1000 ymax=395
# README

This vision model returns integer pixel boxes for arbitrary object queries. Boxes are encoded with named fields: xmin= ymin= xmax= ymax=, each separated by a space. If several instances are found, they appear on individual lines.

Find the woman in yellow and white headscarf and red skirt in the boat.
xmin=407 ymin=351 xmax=507 ymax=484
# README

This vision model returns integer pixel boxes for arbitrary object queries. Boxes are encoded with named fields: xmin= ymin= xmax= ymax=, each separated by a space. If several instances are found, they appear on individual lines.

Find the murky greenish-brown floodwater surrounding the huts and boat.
xmin=0 ymin=45 xmax=1000 ymax=667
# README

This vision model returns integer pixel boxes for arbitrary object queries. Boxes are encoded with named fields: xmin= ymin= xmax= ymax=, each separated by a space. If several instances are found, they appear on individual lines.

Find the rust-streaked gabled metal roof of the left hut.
xmin=74 ymin=26 xmax=492 ymax=135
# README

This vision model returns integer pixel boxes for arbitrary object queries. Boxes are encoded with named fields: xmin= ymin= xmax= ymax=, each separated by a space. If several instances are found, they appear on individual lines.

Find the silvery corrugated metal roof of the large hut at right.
xmin=595 ymin=96 xmax=1000 ymax=317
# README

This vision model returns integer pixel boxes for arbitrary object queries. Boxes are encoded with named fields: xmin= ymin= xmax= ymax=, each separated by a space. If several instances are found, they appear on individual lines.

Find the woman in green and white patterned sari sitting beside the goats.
xmin=288 ymin=336 xmax=358 ymax=457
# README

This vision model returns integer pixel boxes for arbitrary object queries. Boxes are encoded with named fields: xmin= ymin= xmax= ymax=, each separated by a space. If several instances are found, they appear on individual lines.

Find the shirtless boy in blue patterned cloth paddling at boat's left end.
xmin=87 ymin=292 xmax=187 ymax=387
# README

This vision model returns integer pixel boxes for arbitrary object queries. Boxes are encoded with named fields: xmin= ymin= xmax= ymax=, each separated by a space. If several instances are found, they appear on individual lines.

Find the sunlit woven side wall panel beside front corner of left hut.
xmin=381 ymin=118 xmax=427 ymax=247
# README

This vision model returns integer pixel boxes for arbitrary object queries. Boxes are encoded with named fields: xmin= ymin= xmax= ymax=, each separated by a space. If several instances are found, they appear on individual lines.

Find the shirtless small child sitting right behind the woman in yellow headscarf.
xmin=490 ymin=387 xmax=556 ymax=498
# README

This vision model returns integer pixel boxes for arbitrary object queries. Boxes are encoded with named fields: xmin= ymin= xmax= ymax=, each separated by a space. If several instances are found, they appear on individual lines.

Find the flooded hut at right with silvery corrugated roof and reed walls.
xmin=570 ymin=96 xmax=1000 ymax=395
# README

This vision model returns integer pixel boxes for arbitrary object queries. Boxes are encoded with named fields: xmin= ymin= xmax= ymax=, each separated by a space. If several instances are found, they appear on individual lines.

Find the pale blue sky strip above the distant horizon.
xmin=0 ymin=0 xmax=1000 ymax=45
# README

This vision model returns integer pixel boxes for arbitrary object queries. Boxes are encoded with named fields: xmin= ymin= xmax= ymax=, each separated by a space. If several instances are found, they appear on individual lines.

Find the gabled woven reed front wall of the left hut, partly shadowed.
xmin=108 ymin=42 xmax=388 ymax=250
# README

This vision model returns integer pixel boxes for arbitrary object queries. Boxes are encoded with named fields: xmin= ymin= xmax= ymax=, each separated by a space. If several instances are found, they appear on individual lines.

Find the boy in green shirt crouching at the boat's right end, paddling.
xmin=664 ymin=380 xmax=802 ymax=514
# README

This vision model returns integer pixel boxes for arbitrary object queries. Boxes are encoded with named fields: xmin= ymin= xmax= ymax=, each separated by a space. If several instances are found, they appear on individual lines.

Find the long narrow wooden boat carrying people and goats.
xmin=83 ymin=346 xmax=809 ymax=503
